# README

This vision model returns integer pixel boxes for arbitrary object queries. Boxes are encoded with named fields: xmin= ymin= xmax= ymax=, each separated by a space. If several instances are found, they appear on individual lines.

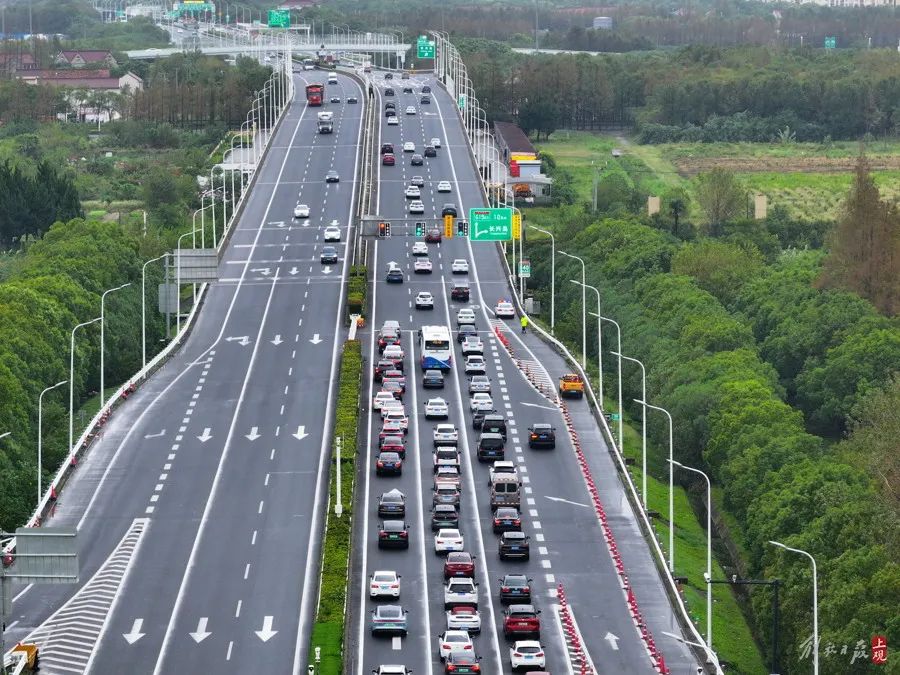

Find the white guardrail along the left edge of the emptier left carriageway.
xmin=0 ymin=62 xmax=291 ymax=664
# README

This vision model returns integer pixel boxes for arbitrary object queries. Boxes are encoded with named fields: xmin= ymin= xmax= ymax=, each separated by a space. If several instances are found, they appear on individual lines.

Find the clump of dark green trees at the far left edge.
xmin=0 ymin=161 xmax=83 ymax=249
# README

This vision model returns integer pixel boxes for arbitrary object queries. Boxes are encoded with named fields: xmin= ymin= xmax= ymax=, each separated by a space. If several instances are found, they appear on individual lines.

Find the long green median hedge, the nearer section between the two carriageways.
xmin=310 ymin=340 xmax=362 ymax=675
